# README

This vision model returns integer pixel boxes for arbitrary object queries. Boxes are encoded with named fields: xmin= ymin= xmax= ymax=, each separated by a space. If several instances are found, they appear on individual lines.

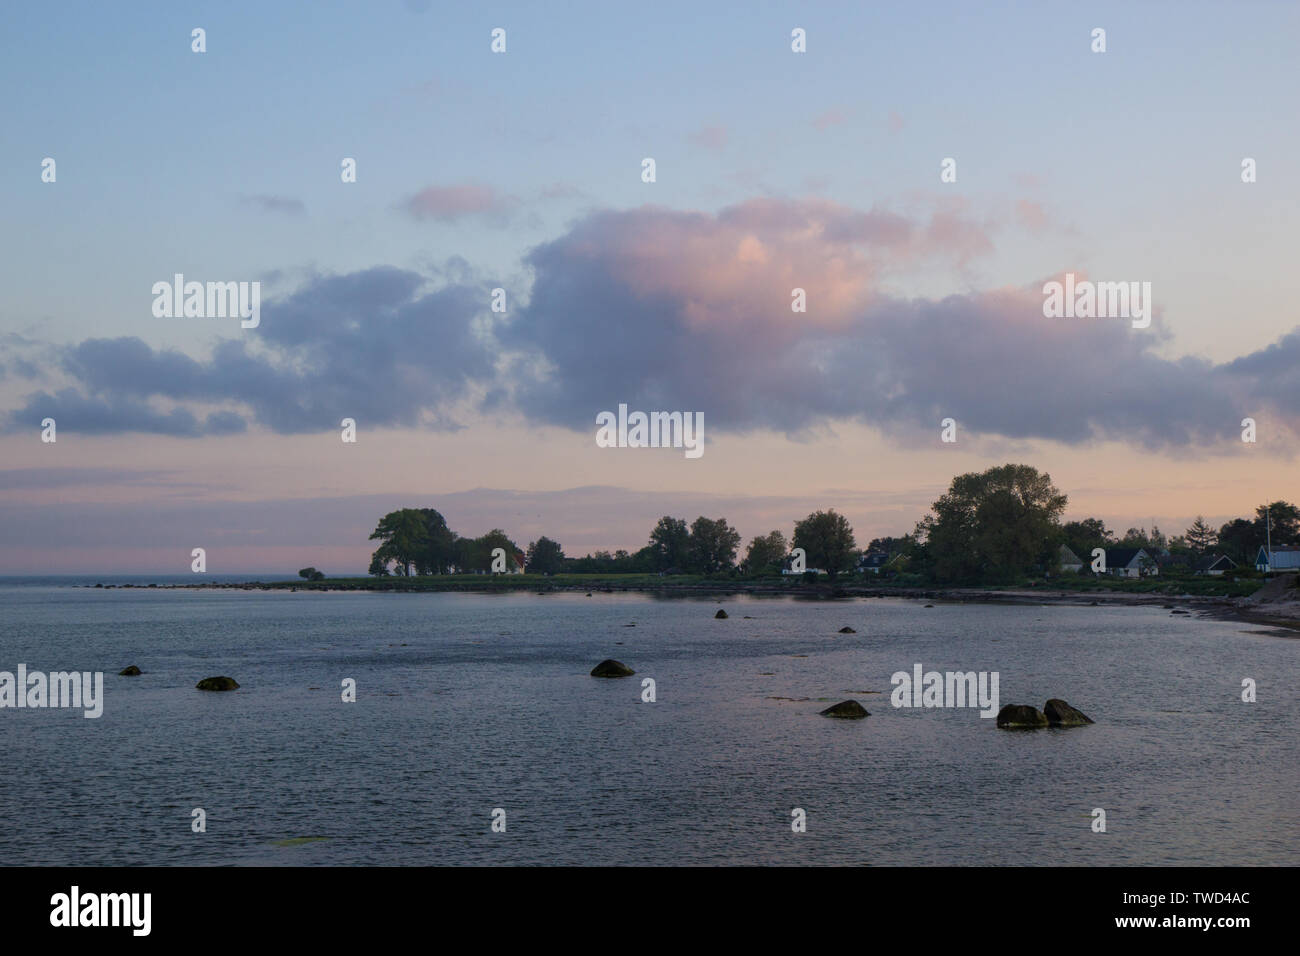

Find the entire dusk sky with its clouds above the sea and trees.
xmin=0 ymin=0 xmax=1300 ymax=574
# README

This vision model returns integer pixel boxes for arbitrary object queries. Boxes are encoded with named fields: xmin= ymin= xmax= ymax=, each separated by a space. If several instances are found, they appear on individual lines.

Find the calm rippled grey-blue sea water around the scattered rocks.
xmin=0 ymin=579 xmax=1300 ymax=865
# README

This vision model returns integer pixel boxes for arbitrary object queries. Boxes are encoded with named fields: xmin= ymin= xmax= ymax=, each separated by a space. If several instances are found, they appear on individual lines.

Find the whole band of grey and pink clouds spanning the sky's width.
xmin=5 ymin=199 xmax=1300 ymax=450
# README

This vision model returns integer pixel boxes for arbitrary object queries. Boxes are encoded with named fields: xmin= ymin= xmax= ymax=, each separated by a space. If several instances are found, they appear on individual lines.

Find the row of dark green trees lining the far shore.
xmin=361 ymin=464 xmax=1300 ymax=585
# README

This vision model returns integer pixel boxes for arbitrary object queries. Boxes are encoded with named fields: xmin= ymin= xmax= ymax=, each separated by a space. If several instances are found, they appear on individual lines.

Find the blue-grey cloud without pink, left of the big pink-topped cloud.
xmin=4 ymin=264 xmax=494 ymax=437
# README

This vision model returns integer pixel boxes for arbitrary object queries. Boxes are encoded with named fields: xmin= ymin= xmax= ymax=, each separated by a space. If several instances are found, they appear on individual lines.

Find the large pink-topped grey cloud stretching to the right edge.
xmin=510 ymin=200 xmax=1300 ymax=447
